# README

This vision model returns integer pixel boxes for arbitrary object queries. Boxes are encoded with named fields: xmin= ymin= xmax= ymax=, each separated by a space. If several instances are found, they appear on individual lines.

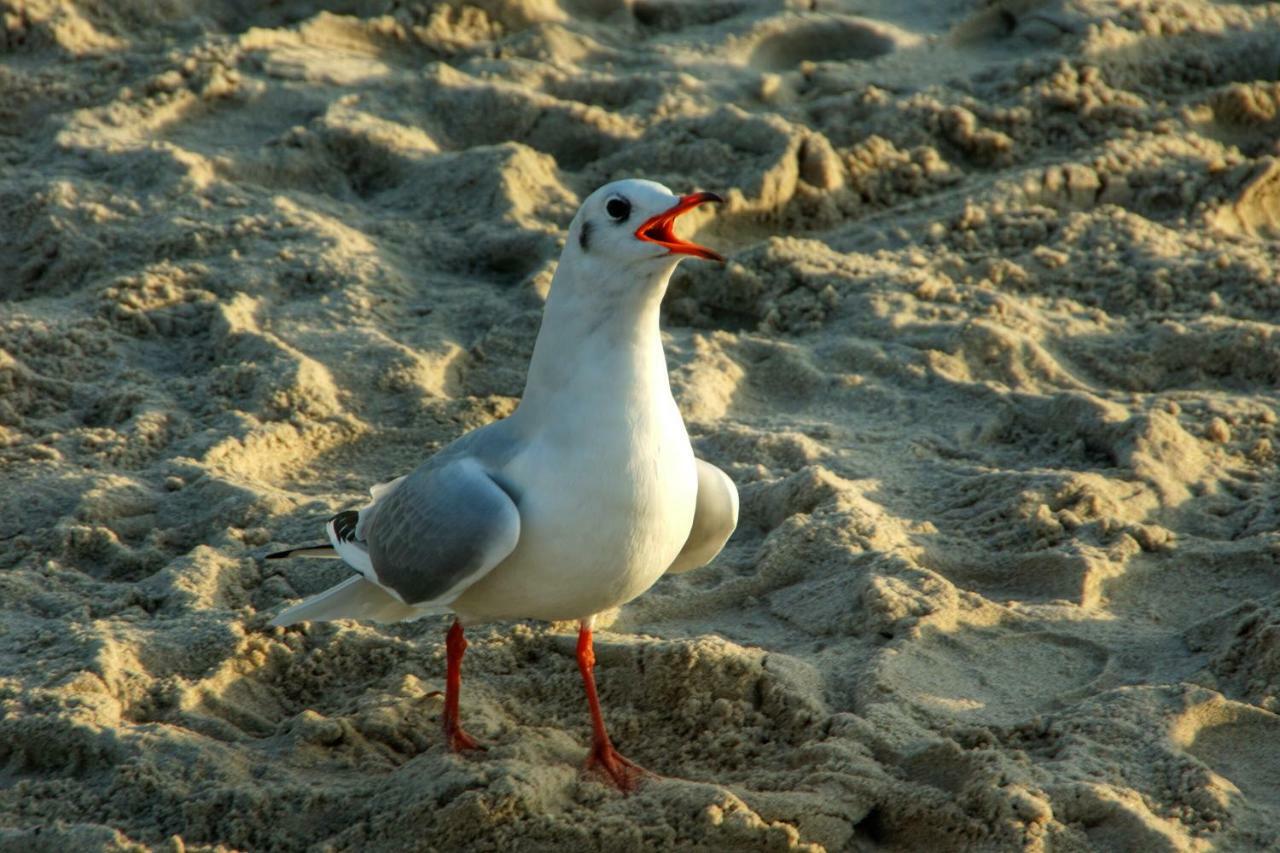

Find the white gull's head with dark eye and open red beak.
xmin=568 ymin=179 xmax=724 ymax=273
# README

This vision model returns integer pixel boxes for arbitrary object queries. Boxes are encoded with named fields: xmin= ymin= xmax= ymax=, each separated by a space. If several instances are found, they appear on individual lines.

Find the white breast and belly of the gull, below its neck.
xmin=453 ymin=398 xmax=698 ymax=622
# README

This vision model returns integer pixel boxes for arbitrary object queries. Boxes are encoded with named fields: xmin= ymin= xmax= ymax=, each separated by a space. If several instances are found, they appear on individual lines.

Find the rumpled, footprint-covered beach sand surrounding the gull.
xmin=0 ymin=0 xmax=1280 ymax=853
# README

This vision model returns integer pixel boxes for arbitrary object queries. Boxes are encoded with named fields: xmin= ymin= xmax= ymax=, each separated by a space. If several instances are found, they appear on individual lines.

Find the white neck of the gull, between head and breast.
xmin=520 ymin=251 xmax=676 ymax=423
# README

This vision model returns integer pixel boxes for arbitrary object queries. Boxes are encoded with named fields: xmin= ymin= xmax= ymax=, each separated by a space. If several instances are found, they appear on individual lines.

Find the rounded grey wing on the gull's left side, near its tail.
xmin=360 ymin=456 xmax=520 ymax=605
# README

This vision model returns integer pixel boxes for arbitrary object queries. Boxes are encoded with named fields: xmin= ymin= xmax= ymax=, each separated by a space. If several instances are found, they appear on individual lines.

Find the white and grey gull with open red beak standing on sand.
xmin=268 ymin=179 xmax=739 ymax=792
